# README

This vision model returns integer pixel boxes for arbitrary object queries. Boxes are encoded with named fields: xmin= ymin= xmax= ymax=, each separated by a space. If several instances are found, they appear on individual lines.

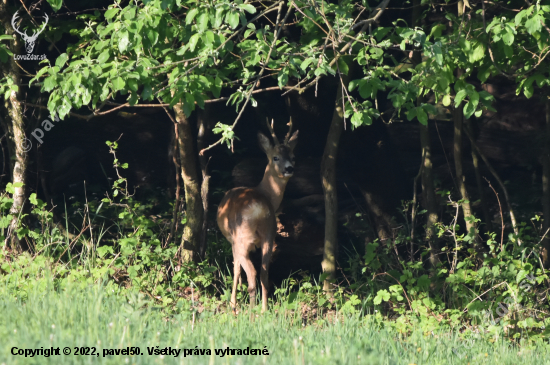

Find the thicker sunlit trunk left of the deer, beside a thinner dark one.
xmin=174 ymin=104 xmax=204 ymax=262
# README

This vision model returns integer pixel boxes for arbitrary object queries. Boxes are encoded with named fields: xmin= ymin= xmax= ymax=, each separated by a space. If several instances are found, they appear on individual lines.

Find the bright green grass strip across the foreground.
xmin=0 ymin=284 xmax=550 ymax=365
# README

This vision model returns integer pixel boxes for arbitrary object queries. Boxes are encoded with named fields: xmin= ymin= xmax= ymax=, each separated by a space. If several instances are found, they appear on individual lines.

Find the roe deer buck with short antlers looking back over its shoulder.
xmin=218 ymin=118 xmax=298 ymax=313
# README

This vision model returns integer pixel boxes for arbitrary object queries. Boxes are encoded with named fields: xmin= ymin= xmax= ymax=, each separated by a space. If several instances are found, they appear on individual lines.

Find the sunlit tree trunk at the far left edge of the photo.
xmin=0 ymin=2 xmax=30 ymax=250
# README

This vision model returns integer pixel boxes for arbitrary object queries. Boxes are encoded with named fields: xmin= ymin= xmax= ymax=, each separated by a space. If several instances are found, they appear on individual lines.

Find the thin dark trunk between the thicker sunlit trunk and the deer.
xmin=197 ymin=106 xmax=210 ymax=258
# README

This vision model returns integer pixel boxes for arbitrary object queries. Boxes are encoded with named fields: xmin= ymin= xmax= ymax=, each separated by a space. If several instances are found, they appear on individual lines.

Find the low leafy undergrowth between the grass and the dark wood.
xmin=0 ymin=142 xmax=550 ymax=346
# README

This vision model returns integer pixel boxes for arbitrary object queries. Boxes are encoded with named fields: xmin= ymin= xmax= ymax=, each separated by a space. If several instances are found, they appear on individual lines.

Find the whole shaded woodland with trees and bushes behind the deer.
xmin=0 ymin=0 xmax=550 ymax=327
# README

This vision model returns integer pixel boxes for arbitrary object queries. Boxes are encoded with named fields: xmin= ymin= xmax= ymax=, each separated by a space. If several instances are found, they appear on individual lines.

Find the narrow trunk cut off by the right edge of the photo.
xmin=542 ymin=97 xmax=550 ymax=267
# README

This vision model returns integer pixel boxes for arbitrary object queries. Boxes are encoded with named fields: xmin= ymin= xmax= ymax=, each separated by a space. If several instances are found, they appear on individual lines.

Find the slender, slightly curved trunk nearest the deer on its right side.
xmin=321 ymin=75 xmax=347 ymax=295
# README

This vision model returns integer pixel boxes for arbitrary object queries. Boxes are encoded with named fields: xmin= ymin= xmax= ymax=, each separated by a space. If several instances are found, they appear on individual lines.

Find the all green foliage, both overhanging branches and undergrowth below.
xmin=0 ymin=0 xmax=550 ymax=361
